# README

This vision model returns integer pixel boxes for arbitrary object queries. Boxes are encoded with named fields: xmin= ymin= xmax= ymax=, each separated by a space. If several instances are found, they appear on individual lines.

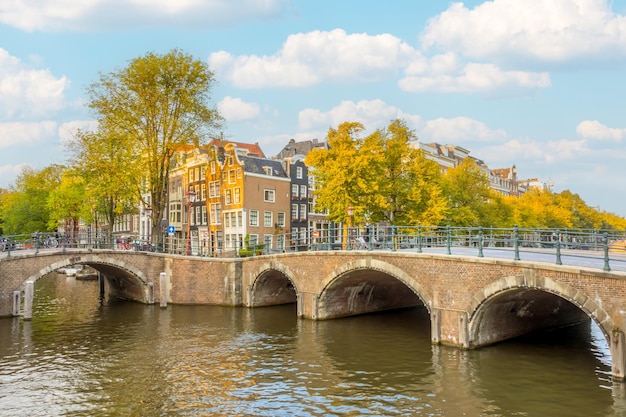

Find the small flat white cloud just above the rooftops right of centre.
xmin=419 ymin=117 xmax=508 ymax=145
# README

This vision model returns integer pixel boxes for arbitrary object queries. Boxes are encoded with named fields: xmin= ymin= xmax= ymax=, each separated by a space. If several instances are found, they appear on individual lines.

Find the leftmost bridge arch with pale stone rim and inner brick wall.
xmin=21 ymin=254 xmax=154 ymax=303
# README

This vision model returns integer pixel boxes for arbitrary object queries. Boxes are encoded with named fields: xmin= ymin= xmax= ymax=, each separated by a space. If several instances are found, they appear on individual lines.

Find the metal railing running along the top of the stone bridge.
xmin=0 ymin=224 xmax=626 ymax=271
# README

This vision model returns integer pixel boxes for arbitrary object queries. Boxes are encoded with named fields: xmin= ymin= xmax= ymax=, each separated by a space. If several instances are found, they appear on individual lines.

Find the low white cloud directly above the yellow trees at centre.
xmin=298 ymin=100 xmax=421 ymax=130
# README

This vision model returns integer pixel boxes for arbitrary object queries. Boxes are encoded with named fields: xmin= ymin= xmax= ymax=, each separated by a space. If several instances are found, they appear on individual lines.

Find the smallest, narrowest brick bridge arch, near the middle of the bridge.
xmin=247 ymin=262 xmax=300 ymax=307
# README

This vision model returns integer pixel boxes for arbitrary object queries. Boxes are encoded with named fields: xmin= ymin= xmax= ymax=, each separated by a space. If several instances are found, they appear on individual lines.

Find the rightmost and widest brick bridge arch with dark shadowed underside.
xmin=468 ymin=276 xmax=615 ymax=348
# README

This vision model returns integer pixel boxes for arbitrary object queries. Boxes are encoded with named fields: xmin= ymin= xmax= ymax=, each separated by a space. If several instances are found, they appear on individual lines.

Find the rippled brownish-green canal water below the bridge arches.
xmin=0 ymin=274 xmax=626 ymax=417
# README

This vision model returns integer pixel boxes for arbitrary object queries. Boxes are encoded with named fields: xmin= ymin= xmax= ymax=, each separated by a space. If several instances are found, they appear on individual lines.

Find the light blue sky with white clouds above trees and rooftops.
xmin=0 ymin=0 xmax=626 ymax=216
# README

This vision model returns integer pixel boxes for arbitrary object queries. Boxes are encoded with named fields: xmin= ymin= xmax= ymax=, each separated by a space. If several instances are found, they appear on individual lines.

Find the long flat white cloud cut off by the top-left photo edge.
xmin=0 ymin=0 xmax=292 ymax=32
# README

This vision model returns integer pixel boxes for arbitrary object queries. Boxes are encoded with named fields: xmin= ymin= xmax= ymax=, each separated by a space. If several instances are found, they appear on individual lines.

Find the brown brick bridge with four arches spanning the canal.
xmin=0 ymin=250 xmax=626 ymax=379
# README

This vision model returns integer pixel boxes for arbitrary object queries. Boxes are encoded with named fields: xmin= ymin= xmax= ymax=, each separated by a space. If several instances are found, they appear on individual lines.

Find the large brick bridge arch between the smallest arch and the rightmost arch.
xmin=316 ymin=257 xmax=431 ymax=319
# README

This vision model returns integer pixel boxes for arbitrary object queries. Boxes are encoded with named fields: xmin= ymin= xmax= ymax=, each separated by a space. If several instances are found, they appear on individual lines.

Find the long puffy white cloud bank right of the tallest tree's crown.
xmin=208 ymin=29 xmax=550 ymax=94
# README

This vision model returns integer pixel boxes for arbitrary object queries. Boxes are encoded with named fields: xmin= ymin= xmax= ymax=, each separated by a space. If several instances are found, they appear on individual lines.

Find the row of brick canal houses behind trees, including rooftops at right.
xmin=106 ymin=139 xmax=536 ymax=256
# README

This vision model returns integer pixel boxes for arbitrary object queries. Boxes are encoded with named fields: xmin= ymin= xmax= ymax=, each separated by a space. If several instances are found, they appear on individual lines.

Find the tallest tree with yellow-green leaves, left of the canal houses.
xmin=88 ymin=49 xmax=222 ymax=242
